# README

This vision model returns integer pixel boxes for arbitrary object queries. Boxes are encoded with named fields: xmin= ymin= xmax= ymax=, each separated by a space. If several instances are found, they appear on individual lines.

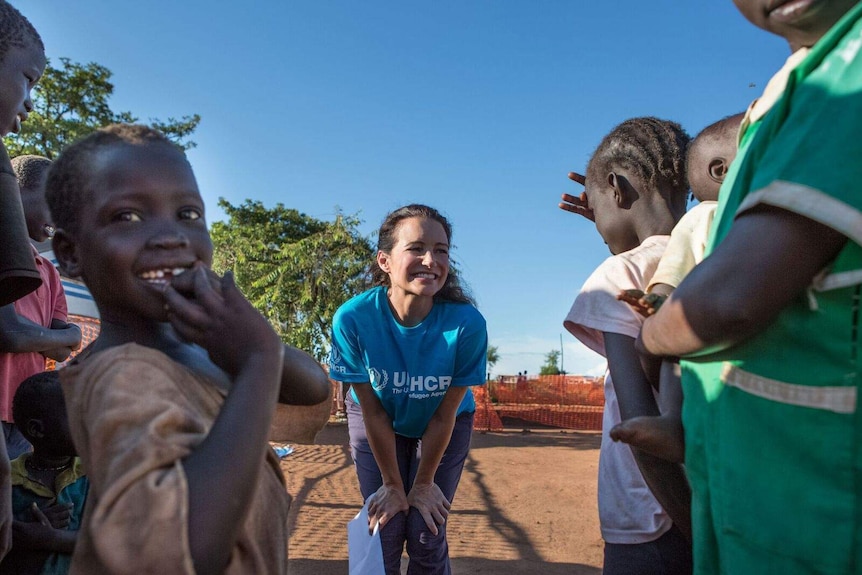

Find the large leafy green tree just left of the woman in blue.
xmin=210 ymin=198 xmax=374 ymax=361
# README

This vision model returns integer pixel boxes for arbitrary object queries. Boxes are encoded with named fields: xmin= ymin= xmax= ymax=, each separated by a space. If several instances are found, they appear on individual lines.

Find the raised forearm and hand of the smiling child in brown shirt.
xmin=165 ymin=266 xmax=283 ymax=573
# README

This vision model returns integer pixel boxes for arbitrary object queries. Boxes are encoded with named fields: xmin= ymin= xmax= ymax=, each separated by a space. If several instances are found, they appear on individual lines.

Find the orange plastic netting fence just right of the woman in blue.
xmin=473 ymin=375 xmax=605 ymax=431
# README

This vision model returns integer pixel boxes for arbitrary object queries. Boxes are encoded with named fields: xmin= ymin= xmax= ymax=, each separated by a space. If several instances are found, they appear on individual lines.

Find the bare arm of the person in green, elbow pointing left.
xmin=639 ymin=206 xmax=847 ymax=356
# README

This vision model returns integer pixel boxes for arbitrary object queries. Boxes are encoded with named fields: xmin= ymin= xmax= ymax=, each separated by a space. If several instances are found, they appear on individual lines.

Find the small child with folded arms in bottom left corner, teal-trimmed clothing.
xmin=0 ymin=371 xmax=89 ymax=574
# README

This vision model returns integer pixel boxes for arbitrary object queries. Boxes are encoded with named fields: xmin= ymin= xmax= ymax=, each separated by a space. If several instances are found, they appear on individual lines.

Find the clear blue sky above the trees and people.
xmin=20 ymin=0 xmax=789 ymax=374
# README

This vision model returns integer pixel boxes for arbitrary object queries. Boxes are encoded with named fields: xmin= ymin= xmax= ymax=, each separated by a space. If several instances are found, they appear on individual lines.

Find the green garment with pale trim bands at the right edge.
xmin=682 ymin=4 xmax=862 ymax=573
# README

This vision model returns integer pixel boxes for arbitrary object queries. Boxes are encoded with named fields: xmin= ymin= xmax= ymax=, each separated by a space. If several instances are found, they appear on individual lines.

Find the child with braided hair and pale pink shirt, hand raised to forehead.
xmin=561 ymin=117 xmax=691 ymax=575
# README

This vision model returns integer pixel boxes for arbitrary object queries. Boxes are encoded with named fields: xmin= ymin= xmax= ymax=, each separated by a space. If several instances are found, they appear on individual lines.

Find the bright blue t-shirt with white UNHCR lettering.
xmin=329 ymin=287 xmax=488 ymax=438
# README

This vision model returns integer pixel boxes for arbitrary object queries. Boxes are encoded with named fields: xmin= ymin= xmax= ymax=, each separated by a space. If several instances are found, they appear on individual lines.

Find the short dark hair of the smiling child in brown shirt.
xmin=45 ymin=124 xmax=188 ymax=234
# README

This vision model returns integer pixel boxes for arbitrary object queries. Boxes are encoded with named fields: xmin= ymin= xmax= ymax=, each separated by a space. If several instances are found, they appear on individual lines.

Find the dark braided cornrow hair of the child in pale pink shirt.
xmin=587 ymin=116 xmax=691 ymax=212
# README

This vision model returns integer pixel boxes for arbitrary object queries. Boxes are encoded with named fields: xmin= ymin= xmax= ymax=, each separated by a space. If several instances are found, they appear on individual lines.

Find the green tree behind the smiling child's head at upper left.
xmin=6 ymin=58 xmax=200 ymax=159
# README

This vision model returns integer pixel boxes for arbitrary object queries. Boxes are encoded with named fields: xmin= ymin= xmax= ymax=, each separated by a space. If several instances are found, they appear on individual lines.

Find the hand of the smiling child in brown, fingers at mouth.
xmin=165 ymin=264 xmax=283 ymax=377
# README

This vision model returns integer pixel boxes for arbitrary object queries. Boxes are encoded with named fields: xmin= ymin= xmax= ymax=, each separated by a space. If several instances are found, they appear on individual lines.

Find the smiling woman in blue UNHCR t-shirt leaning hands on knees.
xmin=330 ymin=204 xmax=488 ymax=575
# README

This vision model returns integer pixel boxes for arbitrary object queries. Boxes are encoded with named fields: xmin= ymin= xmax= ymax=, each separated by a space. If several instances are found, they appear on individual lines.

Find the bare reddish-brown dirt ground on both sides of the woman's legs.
xmin=282 ymin=424 xmax=602 ymax=575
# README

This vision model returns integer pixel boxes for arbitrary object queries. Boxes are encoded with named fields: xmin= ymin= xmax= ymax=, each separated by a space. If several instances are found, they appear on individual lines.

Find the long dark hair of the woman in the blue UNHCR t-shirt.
xmin=371 ymin=204 xmax=476 ymax=305
